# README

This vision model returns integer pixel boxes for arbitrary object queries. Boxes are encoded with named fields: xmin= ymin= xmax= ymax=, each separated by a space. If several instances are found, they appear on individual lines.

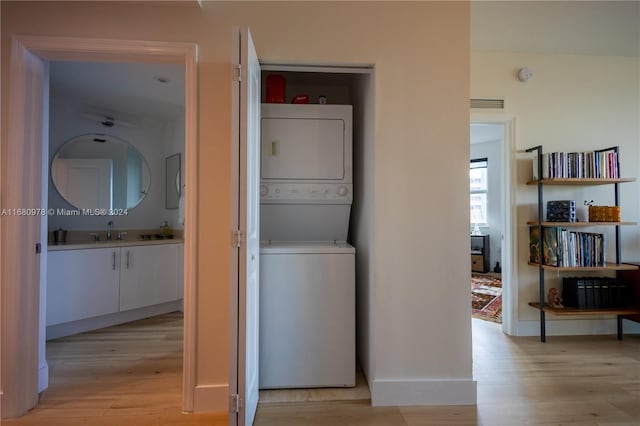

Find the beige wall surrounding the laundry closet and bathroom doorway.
xmin=1 ymin=2 xmax=476 ymax=411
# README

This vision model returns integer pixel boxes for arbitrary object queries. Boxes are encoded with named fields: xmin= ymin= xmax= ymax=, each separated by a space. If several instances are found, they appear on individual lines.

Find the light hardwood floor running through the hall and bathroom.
xmin=2 ymin=314 xmax=640 ymax=426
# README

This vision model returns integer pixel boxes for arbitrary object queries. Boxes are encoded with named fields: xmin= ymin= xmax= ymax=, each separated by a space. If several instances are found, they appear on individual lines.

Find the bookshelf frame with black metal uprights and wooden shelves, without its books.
xmin=526 ymin=145 xmax=640 ymax=342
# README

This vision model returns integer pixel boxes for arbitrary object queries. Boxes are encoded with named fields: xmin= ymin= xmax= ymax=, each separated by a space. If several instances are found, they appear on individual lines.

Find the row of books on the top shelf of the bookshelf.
xmin=533 ymin=149 xmax=620 ymax=180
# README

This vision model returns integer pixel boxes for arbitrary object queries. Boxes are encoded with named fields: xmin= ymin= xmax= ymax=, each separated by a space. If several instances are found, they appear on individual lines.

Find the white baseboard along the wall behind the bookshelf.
xmin=516 ymin=314 xmax=640 ymax=336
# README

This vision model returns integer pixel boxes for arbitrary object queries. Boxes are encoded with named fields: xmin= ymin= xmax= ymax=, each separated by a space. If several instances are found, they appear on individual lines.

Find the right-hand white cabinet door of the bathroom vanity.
xmin=120 ymin=244 xmax=178 ymax=311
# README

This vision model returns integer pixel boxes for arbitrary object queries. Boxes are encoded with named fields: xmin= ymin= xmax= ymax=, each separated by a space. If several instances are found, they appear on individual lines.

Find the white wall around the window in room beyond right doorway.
xmin=471 ymin=139 xmax=504 ymax=271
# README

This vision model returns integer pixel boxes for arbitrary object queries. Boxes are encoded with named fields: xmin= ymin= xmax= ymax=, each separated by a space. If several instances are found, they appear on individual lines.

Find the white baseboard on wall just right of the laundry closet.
xmin=371 ymin=379 xmax=477 ymax=406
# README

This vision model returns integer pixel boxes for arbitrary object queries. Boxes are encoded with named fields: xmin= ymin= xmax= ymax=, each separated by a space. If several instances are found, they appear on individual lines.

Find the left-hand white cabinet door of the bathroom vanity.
xmin=47 ymin=248 xmax=120 ymax=326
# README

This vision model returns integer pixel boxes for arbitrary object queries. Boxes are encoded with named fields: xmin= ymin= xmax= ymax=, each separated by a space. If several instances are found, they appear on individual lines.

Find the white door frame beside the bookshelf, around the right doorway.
xmin=469 ymin=112 xmax=518 ymax=336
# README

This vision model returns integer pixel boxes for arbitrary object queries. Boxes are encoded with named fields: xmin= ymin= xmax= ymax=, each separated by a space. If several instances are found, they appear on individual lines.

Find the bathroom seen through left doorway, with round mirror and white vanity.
xmin=40 ymin=61 xmax=185 ymax=405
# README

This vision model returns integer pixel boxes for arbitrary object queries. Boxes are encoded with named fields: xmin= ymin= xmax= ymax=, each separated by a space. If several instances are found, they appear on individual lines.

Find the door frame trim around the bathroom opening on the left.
xmin=2 ymin=36 xmax=197 ymax=417
